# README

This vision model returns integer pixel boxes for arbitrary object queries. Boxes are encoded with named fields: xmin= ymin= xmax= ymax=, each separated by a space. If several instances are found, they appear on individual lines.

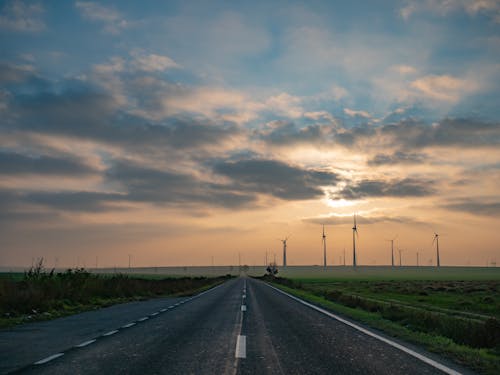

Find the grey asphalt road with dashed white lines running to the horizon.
xmin=0 ymin=277 xmax=470 ymax=374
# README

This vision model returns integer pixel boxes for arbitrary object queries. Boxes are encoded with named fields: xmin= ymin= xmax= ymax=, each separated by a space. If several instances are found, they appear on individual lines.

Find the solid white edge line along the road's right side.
xmin=266 ymin=283 xmax=460 ymax=375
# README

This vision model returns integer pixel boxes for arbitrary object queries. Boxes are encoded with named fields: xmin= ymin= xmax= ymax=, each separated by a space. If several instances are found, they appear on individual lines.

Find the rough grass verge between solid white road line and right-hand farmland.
xmin=265 ymin=278 xmax=500 ymax=375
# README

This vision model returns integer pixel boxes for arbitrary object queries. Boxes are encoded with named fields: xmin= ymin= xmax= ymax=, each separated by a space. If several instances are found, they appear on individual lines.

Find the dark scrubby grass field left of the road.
xmin=0 ymin=264 xmax=231 ymax=328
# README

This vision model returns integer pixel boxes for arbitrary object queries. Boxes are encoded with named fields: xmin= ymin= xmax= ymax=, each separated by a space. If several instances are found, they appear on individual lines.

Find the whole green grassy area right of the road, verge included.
xmin=262 ymin=267 xmax=500 ymax=374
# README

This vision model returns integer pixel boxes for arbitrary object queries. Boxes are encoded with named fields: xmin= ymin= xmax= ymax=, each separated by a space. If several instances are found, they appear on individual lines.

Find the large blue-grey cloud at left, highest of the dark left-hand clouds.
xmin=7 ymin=89 xmax=241 ymax=150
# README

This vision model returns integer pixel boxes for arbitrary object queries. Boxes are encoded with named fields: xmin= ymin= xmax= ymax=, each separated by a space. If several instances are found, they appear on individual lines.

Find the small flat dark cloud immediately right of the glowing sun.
xmin=332 ymin=178 xmax=435 ymax=199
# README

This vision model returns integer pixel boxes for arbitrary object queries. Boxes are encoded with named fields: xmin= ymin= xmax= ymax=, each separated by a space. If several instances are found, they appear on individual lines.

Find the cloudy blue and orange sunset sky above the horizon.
xmin=0 ymin=0 xmax=500 ymax=267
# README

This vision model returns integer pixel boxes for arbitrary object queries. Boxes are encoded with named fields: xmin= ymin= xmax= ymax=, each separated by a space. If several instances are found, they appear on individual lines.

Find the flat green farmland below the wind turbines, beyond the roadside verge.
xmin=282 ymin=267 xmax=500 ymax=319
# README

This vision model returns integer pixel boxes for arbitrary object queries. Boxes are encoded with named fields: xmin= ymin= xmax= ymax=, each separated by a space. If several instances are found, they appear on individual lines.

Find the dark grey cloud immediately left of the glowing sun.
xmin=214 ymin=159 xmax=339 ymax=200
